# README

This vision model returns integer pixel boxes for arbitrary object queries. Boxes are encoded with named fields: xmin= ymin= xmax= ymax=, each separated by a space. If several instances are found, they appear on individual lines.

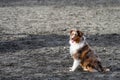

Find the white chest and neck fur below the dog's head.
xmin=70 ymin=40 xmax=85 ymax=56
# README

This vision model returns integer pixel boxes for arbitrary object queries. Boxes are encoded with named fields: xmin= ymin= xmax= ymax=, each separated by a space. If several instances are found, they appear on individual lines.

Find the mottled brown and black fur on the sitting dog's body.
xmin=74 ymin=45 xmax=104 ymax=72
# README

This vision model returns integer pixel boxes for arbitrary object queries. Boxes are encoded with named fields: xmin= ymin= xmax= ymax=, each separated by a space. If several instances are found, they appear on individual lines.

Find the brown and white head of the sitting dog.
xmin=70 ymin=29 xmax=83 ymax=43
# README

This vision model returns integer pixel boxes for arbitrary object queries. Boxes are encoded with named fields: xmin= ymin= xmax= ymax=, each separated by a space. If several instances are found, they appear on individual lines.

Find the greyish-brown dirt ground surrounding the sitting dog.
xmin=0 ymin=0 xmax=120 ymax=80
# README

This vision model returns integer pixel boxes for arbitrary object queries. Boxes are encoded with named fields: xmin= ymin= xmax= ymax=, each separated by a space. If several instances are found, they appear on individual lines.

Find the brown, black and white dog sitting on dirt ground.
xmin=69 ymin=29 xmax=110 ymax=72
